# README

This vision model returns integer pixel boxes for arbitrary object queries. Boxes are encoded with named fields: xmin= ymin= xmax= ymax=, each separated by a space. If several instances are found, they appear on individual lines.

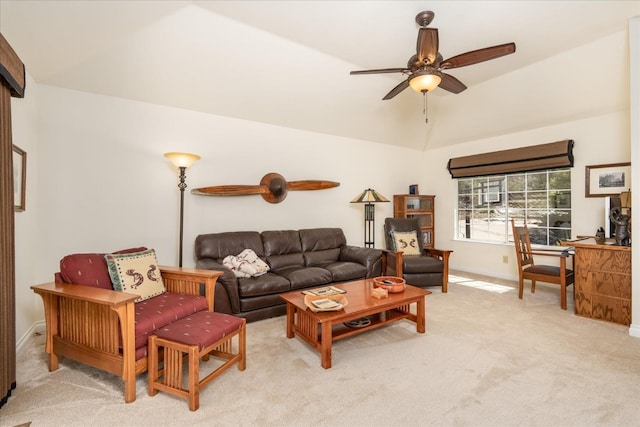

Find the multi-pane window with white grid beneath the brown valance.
xmin=456 ymin=169 xmax=571 ymax=245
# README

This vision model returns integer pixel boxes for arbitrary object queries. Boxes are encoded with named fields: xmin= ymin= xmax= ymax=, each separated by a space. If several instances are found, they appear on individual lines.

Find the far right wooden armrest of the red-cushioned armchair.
xmin=160 ymin=265 xmax=223 ymax=311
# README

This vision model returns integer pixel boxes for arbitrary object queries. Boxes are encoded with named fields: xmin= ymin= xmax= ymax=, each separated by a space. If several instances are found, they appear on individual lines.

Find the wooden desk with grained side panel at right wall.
xmin=563 ymin=238 xmax=631 ymax=326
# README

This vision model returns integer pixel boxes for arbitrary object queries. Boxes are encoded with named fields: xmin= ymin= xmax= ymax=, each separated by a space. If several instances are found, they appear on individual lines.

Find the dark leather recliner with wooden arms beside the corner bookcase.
xmin=383 ymin=218 xmax=453 ymax=293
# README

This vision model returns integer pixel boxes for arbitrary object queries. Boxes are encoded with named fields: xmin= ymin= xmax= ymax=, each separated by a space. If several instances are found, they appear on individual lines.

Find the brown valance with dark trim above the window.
xmin=447 ymin=139 xmax=573 ymax=178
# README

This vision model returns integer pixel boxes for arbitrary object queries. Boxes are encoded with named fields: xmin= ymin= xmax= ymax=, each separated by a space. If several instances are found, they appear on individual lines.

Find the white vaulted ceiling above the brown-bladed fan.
xmin=0 ymin=0 xmax=640 ymax=149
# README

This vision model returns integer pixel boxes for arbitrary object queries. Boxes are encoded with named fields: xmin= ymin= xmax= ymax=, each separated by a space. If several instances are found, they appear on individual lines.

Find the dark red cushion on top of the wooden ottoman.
xmin=156 ymin=311 xmax=242 ymax=350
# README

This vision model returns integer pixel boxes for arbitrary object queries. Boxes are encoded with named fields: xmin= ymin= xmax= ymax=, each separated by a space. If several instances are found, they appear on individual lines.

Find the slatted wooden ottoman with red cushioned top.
xmin=149 ymin=311 xmax=246 ymax=411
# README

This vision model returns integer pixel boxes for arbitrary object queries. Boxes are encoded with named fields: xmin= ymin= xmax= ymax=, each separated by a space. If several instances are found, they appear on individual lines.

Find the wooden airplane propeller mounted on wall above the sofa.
xmin=191 ymin=172 xmax=340 ymax=203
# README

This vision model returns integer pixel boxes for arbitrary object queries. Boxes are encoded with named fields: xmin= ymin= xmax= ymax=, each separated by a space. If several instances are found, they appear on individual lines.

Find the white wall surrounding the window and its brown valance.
xmin=421 ymin=111 xmax=630 ymax=280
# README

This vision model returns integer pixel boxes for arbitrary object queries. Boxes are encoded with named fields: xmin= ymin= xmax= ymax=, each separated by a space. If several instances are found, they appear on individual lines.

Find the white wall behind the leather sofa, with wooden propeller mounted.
xmin=15 ymin=84 xmax=422 ymax=344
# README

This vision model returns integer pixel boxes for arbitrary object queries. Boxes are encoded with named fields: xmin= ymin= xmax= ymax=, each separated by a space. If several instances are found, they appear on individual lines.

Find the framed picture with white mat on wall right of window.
xmin=584 ymin=162 xmax=631 ymax=197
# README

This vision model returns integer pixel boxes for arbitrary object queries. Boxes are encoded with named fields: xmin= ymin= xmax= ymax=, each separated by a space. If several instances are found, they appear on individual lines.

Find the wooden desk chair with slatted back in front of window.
xmin=511 ymin=219 xmax=574 ymax=310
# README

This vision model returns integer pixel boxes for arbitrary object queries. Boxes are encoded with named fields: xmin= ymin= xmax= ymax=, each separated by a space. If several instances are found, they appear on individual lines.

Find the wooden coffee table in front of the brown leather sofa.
xmin=281 ymin=279 xmax=431 ymax=369
